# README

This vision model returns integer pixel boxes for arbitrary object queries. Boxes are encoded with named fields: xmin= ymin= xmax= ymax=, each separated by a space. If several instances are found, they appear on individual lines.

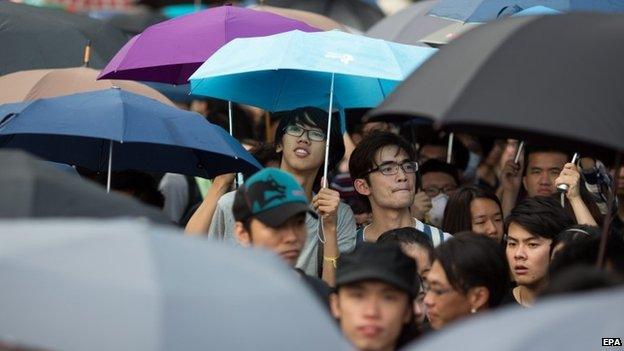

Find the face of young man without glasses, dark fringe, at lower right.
xmin=505 ymin=222 xmax=552 ymax=287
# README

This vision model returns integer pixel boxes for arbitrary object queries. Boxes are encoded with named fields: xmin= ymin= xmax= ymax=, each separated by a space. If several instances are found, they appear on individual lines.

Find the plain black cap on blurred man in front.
xmin=336 ymin=243 xmax=416 ymax=296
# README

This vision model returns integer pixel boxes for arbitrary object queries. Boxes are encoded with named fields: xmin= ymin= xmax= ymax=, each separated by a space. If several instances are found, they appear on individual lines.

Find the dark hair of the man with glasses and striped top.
xmin=349 ymin=132 xmax=416 ymax=180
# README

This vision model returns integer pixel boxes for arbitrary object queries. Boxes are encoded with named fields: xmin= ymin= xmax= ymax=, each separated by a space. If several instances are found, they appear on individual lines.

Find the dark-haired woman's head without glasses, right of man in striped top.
xmin=442 ymin=186 xmax=504 ymax=243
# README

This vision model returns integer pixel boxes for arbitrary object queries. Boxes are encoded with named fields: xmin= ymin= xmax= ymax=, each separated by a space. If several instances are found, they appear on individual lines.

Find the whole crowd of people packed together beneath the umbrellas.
xmin=96 ymin=107 xmax=624 ymax=351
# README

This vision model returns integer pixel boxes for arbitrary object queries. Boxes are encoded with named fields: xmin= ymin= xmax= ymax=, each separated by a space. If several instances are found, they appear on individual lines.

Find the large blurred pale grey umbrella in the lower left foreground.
xmin=0 ymin=220 xmax=349 ymax=351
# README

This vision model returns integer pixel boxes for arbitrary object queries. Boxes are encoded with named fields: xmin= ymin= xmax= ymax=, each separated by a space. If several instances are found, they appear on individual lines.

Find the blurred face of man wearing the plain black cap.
xmin=331 ymin=281 xmax=412 ymax=351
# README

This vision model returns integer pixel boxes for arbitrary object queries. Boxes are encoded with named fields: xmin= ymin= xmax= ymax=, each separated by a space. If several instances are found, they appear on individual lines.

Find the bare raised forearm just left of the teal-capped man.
xmin=184 ymin=173 xmax=236 ymax=236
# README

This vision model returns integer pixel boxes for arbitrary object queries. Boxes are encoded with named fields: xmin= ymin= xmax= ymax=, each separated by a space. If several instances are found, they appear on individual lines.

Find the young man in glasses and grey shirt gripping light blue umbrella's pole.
xmin=207 ymin=107 xmax=355 ymax=285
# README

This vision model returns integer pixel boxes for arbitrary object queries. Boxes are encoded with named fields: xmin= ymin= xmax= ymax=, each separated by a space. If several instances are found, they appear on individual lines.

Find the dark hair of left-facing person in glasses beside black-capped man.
xmin=435 ymin=232 xmax=509 ymax=308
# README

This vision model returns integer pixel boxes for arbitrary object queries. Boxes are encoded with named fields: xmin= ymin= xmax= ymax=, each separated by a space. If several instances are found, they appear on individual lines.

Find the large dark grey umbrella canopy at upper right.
xmin=372 ymin=13 xmax=624 ymax=155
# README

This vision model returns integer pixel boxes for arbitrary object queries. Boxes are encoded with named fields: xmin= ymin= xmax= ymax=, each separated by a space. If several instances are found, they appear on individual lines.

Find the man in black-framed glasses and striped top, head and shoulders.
xmin=349 ymin=133 xmax=451 ymax=246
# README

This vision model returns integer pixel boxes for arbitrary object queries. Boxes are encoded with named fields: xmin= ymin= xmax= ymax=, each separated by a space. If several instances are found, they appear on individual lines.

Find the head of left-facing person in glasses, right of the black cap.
xmin=424 ymin=232 xmax=509 ymax=330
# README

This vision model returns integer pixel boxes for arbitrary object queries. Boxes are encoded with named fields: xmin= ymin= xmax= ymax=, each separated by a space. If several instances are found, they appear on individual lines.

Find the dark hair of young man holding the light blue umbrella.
xmin=273 ymin=107 xmax=345 ymax=186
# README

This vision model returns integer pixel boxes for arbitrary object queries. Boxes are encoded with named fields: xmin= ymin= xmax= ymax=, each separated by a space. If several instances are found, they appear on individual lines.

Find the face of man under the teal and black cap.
xmin=236 ymin=213 xmax=307 ymax=267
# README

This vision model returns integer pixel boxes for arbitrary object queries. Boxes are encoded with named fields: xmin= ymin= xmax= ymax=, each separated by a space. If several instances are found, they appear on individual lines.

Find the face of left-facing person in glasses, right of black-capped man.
xmin=424 ymin=260 xmax=470 ymax=329
